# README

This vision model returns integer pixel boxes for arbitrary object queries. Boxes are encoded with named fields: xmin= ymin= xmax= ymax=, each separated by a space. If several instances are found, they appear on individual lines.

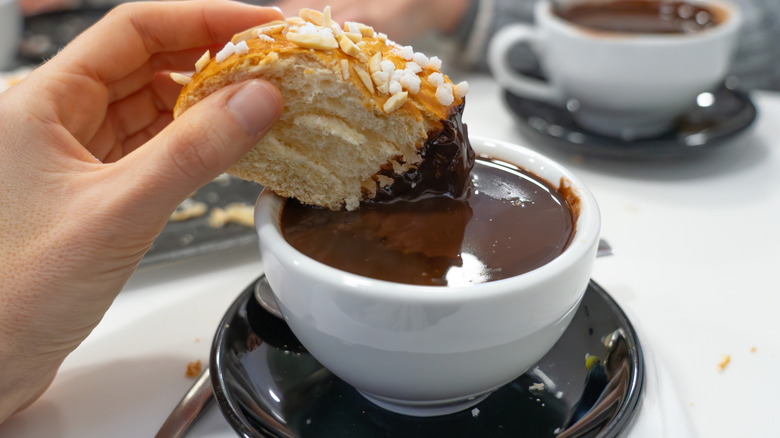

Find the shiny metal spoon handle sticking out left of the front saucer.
xmin=155 ymin=367 xmax=214 ymax=438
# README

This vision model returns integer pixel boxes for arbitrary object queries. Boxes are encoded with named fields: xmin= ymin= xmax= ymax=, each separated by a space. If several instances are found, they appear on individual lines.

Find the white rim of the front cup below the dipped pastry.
xmin=254 ymin=136 xmax=601 ymax=304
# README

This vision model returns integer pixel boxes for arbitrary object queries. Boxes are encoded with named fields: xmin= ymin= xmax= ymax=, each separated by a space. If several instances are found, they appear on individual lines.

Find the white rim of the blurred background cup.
xmin=534 ymin=0 xmax=742 ymax=45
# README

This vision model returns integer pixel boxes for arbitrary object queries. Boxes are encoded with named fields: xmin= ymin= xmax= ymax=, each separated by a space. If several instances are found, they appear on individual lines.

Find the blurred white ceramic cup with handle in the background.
xmin=488 ymin=0 xmax=741 ymax=140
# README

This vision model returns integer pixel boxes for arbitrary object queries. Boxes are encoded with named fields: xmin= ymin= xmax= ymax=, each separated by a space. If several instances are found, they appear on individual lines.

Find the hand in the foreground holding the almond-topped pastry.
xmin=0 ymin=0 xmax=282 ymax=422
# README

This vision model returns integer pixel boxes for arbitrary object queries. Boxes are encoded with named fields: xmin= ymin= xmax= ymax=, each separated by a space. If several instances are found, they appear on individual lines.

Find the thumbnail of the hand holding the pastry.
xmin=227 ymin=80 xmax=279 ymax=135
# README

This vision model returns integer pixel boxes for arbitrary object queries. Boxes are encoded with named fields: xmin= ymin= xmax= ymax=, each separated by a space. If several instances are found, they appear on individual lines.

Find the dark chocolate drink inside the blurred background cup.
xmin=559 ymin=0 xmax=719 ymax=33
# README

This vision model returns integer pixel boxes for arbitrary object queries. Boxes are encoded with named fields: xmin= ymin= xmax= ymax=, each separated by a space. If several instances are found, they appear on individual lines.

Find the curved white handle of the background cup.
xmin=487 ymin=23 xmax=564 ymax=103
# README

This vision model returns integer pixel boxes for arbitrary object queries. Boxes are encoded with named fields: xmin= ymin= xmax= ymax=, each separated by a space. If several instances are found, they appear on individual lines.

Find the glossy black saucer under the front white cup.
xmin=210 ymin=277 xmax=644 ymax=438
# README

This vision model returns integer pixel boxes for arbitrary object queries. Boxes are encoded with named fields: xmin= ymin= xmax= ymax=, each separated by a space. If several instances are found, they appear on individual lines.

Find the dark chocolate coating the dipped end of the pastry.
xmin=371 ymin=102 xmax=474 ymax=202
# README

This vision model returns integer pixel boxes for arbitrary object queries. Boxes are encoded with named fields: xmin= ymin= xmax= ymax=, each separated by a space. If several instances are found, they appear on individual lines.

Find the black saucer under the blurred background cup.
xmin=504 ymin=85 xmax=757 ymax=159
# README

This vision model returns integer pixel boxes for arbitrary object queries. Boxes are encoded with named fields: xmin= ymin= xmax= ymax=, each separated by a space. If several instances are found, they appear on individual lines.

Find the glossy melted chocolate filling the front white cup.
xmin=281 ymin=157 xmax=577 ymax=285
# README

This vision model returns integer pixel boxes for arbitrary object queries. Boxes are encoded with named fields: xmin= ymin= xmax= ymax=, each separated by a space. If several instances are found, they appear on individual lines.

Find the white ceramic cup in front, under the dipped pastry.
xmin=255 ymin=138 xmax=601 ymax=416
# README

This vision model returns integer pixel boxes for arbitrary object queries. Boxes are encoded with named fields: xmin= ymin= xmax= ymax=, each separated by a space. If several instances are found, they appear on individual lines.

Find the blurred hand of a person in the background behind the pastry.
xmin=276 ymin=0 xmax=468 ymax=43
